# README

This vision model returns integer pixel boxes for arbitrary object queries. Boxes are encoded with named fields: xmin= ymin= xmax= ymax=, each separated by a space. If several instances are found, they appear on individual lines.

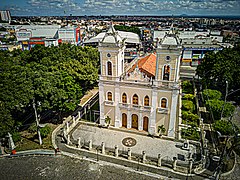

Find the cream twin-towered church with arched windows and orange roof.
xmin=98 ymin=26 xmax=182 ymax=138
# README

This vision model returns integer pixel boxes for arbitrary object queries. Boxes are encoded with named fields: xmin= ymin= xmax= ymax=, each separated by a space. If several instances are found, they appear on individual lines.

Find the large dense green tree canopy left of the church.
xmin=0 ymin=44 xmax=99 ymax=136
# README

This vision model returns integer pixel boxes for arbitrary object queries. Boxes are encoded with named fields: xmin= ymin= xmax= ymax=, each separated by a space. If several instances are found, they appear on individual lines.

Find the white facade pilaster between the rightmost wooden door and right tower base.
xmin=148 ymin=88 xmax=158 ymax=135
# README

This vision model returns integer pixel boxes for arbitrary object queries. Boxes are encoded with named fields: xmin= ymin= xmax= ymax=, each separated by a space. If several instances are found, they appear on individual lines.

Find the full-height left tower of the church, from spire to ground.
xmin=98 ymin=25 xmax=125 ymax=127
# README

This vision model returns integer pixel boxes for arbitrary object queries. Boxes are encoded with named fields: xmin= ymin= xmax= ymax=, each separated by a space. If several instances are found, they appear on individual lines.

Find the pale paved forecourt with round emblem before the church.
xmin=72 ymin=124 xmax=196 ymax=159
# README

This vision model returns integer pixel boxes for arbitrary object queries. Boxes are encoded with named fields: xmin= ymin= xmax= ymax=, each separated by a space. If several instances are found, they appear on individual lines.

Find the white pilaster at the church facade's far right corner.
xmin=168 ymin=89 xmax=179 ymax=138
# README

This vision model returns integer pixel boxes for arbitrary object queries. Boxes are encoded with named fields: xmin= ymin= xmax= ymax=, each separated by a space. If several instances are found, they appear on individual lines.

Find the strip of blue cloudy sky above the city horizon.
xmin=0 ymin=0 xmax=240 ymax=16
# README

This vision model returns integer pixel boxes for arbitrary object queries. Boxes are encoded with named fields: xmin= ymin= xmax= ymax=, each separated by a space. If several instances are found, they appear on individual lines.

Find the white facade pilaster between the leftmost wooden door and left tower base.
xmin=114 ymin=84 xmax=122 ymax=127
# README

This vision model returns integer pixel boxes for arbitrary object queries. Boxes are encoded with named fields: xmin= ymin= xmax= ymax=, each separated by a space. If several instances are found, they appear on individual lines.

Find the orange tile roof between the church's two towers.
xmin=128 ymin=54 xmax=157 ymax=77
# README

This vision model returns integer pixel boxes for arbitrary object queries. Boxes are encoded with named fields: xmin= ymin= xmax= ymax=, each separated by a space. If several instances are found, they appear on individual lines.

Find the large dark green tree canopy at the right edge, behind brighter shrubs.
xmin=197 ymin=45 xmax=240 ymax=98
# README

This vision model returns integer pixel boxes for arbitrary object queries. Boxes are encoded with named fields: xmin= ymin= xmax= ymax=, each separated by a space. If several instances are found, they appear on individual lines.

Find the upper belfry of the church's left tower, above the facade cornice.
xmin=98 ymin=25 xmax=125 ymax=80
